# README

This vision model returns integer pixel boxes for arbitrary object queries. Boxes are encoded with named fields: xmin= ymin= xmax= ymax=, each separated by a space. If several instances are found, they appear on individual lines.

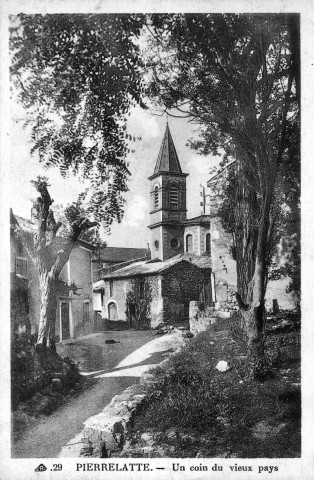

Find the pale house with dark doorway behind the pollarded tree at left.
xmin=11 ymin=213 xmax=94 ymax=341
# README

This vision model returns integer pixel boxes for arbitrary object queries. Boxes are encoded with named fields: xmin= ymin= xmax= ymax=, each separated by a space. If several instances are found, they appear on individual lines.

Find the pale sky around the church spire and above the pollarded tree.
xmin=9 ymin=101 xmax=218 ymax=247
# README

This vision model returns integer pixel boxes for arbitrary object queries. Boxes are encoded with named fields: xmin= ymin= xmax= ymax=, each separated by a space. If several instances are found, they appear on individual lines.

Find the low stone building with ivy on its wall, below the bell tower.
xmin=102 ymin=255 xmax=208 ymax=328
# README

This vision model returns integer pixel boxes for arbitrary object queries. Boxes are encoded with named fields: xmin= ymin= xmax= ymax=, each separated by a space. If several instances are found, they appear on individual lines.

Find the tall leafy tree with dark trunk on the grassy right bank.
xmin=146 ymin=14 xmax=300 ymax=367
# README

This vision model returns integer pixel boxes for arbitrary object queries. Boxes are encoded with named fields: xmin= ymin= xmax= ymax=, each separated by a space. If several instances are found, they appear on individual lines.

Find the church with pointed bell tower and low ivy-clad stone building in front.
xmin=94 ymin=124 xmax=213 ymax=328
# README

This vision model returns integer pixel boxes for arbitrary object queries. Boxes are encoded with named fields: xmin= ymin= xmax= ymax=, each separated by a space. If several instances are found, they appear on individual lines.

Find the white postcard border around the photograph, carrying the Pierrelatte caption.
xmin=0 ymin=0 xmax=314 ymax=480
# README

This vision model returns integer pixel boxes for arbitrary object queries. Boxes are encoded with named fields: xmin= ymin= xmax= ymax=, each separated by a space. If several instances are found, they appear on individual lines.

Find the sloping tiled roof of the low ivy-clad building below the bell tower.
xmin=103 ymin=254 xmax=190 ymax=280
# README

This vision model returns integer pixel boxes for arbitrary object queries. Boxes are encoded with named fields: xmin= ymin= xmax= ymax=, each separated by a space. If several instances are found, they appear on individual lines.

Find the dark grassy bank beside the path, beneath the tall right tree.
xmin=124 ymin=321 xmax=301 ymax=458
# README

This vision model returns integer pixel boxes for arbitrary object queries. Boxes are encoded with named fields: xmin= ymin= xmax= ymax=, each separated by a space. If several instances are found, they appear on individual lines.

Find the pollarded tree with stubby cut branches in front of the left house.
xmin=11 ymin=177 xmax=97 ymax=347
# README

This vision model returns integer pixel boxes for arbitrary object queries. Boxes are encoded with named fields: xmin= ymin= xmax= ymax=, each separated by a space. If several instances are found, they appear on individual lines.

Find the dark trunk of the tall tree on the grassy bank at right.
xmin=236 ymin=172 xmax=271 ymax=376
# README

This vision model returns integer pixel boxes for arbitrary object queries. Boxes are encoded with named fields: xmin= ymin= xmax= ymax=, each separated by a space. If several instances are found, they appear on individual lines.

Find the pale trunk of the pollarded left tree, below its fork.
xmin=36 ymin=271 xmax=57 ymax=350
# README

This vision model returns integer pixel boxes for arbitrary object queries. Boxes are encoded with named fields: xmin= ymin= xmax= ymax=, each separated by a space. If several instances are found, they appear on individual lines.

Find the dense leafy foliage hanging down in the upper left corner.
xmin=10 ymin=14 xmax=143 ymax=225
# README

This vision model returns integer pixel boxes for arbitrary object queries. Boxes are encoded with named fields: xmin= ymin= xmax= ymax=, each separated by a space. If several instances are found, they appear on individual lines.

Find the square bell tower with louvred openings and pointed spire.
xmin=148 ymin=123 xmax=188 ymax=260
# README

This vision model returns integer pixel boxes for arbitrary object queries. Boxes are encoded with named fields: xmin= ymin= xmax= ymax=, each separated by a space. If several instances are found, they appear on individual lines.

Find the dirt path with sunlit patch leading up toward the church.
xmin=12 ymin=331 xmax=182 ymax=458
